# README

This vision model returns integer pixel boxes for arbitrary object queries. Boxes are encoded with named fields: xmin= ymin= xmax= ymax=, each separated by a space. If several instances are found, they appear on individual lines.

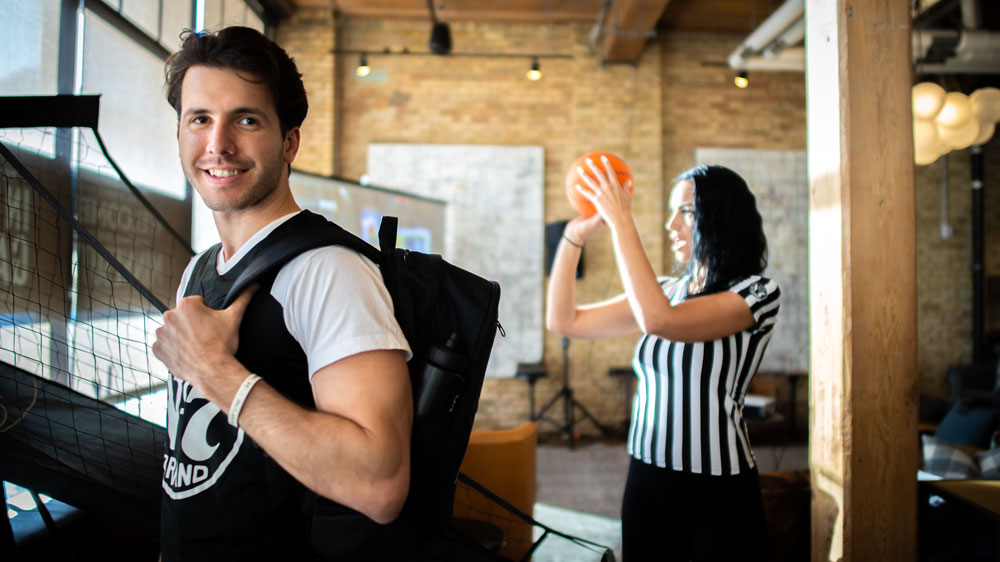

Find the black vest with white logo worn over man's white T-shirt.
xmin=161 ymin=212 xmax=414 ymax=562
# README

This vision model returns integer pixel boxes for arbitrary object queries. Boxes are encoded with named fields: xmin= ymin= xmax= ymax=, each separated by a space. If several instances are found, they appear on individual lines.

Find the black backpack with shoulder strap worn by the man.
xmin=223 ymin=211 xmax=503 ymax=540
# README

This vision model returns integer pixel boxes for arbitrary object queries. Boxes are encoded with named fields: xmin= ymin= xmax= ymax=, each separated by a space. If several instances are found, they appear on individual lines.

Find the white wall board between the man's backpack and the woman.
xmin=368 ymin=144 xmax=545 ymax=376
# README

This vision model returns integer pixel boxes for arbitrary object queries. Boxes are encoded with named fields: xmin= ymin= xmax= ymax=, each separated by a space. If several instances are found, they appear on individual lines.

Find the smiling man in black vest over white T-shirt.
xmin=153 ymin=27 xmax=413 ymax=562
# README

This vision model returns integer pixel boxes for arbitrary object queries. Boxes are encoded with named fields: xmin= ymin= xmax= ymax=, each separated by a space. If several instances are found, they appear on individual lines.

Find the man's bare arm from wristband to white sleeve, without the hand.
xmin=239 ymin=351 xmax=413 ymax=523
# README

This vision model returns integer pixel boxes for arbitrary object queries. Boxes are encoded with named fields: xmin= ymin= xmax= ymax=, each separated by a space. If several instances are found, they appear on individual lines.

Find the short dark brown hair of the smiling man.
xmin=164 ymin=27 xmax=309 ymax=135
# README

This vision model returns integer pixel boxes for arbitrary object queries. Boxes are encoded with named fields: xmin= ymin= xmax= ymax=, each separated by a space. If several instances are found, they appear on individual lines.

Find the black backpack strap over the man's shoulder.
xmin=222 ymin=211 xmax=385 ymax=308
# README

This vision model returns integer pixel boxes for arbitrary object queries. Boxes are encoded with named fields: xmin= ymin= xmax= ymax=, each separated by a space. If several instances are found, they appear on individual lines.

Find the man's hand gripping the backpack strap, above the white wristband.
xmin=153 ymin=285 xmax=258 ymax=400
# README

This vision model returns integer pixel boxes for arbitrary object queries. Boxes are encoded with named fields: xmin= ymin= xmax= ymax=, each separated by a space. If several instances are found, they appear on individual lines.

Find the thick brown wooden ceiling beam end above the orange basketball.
xmin=601 ymin=0 xmax=670 ymax=62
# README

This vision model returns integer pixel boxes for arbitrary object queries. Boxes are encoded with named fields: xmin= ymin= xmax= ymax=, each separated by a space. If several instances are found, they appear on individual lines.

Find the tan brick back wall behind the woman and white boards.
xmin=277 ymin=13 xmax=984 ymax=434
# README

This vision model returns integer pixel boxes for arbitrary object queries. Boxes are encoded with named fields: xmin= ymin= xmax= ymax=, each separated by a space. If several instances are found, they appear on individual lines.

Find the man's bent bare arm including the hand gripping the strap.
xmin=153 ymin=290 xmax=413 ymax=523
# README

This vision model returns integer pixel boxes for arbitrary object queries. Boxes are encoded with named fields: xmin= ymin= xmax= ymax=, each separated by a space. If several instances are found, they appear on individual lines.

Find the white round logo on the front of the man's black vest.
xmin=163 ymin=376 xmax=244 ymax=500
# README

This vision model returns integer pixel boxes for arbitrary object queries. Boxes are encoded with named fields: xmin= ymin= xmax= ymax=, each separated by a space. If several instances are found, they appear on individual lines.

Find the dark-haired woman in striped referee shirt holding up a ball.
xmin=546 ymin=160 xmax=780 ymax=562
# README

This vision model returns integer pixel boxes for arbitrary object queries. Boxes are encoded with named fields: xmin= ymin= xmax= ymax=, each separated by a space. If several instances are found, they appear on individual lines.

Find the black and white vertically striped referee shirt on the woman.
xmin=628 ymin=275 xmax=781 ymax=475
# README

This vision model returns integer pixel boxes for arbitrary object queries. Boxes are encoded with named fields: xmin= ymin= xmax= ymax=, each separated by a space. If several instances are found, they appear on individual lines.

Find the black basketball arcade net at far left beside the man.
xmin=0 ymin=106 xmax=191 ymax=536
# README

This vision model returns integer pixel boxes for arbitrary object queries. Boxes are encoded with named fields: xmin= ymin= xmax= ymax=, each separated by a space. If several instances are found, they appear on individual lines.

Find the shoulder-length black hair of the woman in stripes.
xmin=674 ymin=166 xmax=767 ymax=295
